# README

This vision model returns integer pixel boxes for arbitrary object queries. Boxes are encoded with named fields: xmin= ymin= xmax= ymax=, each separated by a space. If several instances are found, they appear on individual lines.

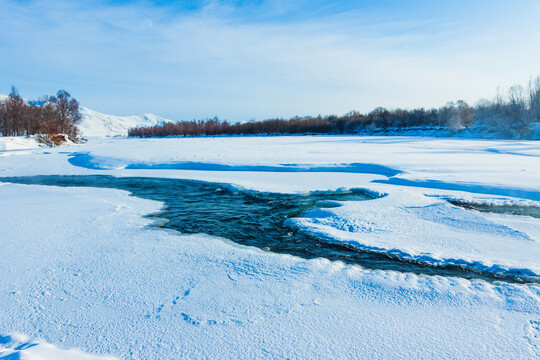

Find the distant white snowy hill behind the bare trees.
xmin=78 ymin=106 xmax=172 ymax=137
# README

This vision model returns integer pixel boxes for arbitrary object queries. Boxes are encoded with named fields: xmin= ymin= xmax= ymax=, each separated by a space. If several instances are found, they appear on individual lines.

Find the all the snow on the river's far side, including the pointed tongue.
xmin=0 ymin=137 xmax=540 ymax=275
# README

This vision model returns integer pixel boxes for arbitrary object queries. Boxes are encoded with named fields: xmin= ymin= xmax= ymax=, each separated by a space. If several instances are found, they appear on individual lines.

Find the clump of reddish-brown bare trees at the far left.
xmin=0 ymin=87 xmax=81 ymax=138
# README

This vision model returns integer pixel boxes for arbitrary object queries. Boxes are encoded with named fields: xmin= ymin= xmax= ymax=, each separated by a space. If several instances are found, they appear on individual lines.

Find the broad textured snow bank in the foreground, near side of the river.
xmin=0 ymin=184 xmax=540 ymax=359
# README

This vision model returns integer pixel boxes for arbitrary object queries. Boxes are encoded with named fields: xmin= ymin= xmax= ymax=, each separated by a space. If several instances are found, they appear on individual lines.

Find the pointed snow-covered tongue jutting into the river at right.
xmin=287 ymin=190 xmax=540 ymax=276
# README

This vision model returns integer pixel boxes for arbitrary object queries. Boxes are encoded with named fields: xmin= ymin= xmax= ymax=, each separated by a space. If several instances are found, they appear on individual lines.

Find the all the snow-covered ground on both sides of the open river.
xmin=0 ymin=136 xmax=540 ymax=359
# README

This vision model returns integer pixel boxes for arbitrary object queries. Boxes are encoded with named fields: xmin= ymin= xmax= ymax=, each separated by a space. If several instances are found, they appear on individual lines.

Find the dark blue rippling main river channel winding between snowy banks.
xmin=0 ymin=175 xmax=539 ymax=283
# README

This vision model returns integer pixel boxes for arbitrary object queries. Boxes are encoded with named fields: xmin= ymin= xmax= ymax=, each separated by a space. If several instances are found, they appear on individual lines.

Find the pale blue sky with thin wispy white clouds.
xmin=0 ymin=0 xmax=540 ymax=122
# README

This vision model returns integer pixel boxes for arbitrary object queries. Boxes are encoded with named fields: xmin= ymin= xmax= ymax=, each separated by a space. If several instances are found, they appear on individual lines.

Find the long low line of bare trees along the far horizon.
xmin=128 ymin=76 xmax=540 ymax=137
